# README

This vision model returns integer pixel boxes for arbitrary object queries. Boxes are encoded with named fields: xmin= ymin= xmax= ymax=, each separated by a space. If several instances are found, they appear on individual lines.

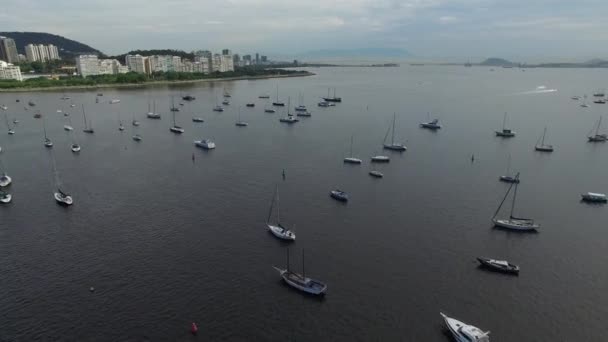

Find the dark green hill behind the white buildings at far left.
xmin=0 ymin=32 xmax=102 ymax=58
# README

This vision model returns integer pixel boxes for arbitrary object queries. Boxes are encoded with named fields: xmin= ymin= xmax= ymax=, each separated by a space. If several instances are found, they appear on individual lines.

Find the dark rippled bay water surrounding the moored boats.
xmin=0 ymin=67 xmax=608 ymax=341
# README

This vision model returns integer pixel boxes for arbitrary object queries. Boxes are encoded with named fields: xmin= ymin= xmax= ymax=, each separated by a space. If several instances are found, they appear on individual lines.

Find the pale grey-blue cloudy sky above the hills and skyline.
xmin=0 ymin=0 xmax=608 ymax=61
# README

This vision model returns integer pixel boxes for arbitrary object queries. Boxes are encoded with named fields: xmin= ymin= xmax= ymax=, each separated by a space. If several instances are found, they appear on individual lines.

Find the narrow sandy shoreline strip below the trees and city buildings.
xmin=0 ymin=71 xmax=315 ymax=93
